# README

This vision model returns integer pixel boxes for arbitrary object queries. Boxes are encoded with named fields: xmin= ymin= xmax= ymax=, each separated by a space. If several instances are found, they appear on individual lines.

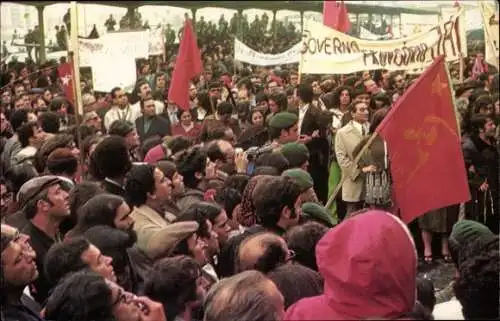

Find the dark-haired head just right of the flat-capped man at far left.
xmin=66 ymin=193 xmax=135 ymax=237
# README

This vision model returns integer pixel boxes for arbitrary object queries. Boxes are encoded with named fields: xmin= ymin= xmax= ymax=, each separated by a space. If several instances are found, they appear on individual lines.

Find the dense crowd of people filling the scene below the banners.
xmin=0 ymin=10 xmax=500 ymax=321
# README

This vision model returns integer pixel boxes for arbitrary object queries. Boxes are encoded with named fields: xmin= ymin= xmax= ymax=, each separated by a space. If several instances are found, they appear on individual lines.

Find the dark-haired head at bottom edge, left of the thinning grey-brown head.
xmin=144 ymin=255 xmax=205 ymax=321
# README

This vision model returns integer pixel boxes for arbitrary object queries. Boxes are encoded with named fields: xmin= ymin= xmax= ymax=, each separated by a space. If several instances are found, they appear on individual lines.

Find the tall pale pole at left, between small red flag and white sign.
xmin=68 ymin=1 xmax=85 ymax=174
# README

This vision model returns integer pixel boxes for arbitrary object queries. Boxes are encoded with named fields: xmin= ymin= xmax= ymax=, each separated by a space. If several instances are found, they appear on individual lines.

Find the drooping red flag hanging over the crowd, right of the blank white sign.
xmin=168 ymin=19 xmax=203 ymax=110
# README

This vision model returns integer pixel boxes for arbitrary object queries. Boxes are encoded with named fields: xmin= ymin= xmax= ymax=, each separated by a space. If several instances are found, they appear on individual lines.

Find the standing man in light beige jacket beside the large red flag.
xmin=335 ymin=101 xmax=371 ymax=215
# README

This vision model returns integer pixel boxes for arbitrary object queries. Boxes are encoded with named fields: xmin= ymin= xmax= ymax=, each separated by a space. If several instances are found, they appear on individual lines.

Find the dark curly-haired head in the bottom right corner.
xmin=454 ymin=236 xmax=500 ymax=320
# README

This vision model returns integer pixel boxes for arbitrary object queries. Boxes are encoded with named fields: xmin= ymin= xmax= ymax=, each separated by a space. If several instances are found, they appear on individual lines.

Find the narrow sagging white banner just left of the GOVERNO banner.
xmin=234 ymin=38 xmax=302 ymax=66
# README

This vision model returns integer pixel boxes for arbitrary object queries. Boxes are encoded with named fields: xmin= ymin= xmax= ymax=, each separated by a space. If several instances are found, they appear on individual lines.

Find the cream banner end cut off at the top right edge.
xmin=479 ymin=1 xmax=500 ymax=68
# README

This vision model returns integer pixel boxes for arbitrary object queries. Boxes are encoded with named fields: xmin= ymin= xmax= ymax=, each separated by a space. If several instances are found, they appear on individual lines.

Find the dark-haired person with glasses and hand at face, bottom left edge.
xmin=45 ymin=270 xmax=166 ymax=321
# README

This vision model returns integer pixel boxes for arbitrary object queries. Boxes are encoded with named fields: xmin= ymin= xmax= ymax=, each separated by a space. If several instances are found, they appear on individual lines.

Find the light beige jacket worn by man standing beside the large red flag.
xmin=335 ymin=121 xmax=364 ymax=202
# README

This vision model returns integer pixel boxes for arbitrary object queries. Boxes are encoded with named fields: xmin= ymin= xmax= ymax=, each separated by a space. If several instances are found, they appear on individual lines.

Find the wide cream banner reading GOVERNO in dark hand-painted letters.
xmin=300 ymin=11 xmax=467 ymax=74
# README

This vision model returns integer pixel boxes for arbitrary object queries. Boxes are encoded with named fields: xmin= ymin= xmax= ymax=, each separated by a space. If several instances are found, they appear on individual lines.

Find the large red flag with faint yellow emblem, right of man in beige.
xmin=377 ymin=56 xmax=470 ymax=223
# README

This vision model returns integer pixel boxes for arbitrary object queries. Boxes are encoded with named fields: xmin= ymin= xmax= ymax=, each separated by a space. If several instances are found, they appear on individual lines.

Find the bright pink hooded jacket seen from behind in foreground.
xmin=284 ymin=210 xmax=417 ymax=320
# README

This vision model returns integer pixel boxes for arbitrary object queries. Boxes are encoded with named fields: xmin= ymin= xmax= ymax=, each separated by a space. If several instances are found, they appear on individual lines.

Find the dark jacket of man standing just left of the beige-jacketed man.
xmin=300 ymin=105 xmax=330 ymax=204
